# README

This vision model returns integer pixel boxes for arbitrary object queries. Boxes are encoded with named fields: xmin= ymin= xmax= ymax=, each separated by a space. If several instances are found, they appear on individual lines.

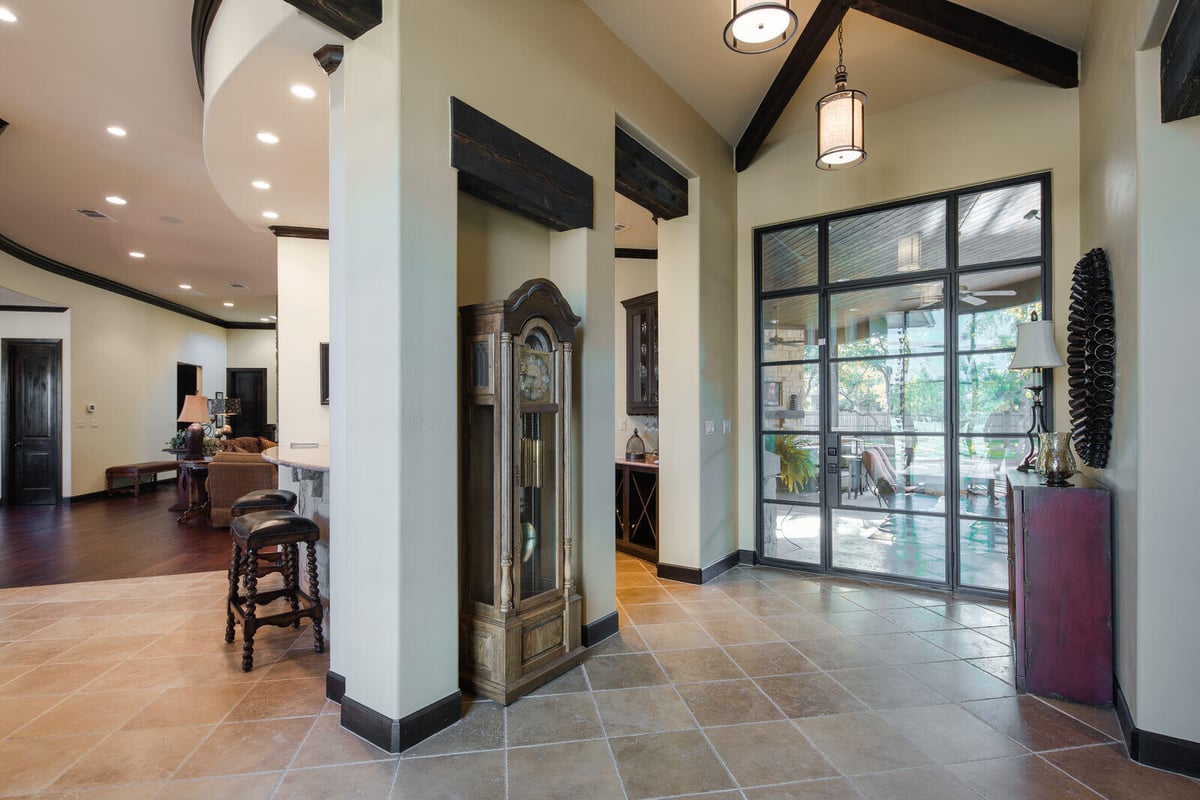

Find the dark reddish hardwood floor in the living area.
xmin=0 ymin=481 xmax=230 ymax=588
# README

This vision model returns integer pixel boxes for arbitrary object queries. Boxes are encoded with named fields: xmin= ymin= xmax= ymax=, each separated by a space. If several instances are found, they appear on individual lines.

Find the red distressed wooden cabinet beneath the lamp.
xmin=1008 ymin=470 xmax=1112 ymax=705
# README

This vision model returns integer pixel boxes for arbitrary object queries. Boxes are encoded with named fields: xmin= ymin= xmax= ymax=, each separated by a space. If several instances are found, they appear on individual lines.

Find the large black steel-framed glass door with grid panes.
xmin=755 ymin=176 xmax=1049 ymax=591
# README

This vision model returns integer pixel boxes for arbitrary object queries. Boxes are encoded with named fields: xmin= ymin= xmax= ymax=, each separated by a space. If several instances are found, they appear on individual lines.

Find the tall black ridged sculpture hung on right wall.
xmin=1067 ymin=247 xmax=1117 ymax=469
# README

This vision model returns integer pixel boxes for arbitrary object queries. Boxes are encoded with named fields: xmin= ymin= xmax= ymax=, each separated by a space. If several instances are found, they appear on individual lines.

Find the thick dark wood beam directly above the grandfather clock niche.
xmin=450 ymin=97 xmax=594 ymax=230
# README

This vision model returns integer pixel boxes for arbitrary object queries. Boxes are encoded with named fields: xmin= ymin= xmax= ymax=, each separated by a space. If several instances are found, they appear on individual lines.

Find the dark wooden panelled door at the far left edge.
xmin=4 ymin=339 xmax=62 ymax=505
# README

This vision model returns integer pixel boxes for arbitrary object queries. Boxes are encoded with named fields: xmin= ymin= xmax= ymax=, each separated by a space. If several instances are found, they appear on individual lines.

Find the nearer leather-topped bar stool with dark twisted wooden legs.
xmin=226 ymin=510 xmax=325 ymax=672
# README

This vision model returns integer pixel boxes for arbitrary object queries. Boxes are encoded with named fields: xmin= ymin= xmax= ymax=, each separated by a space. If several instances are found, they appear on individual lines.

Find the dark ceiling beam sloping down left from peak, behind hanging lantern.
xmin=733 ymin=0 xmax=850 ymax=173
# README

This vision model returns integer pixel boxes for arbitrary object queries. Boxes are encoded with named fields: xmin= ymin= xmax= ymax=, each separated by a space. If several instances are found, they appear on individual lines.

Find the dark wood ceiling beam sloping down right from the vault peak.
xmin=851 ymin=0 xmax=1079 ymax=89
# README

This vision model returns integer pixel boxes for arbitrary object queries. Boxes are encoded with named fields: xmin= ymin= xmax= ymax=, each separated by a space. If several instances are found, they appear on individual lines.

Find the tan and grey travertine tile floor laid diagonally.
xmin=0 ymin=557 xmax=1200 ymax=800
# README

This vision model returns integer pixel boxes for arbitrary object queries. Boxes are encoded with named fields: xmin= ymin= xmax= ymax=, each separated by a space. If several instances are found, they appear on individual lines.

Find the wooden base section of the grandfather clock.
xmin=460 ymin=595 xmax=587 ymax=705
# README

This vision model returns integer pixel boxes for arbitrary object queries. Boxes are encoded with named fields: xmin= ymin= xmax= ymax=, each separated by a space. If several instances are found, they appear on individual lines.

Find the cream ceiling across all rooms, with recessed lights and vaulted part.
xmin=0 ymin=0 xmax=1091 ymax=321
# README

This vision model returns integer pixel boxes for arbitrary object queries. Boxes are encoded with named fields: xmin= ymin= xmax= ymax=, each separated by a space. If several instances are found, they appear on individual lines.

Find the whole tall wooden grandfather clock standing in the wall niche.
xmin=458 ymin=278 xmax=583 ymax=704
